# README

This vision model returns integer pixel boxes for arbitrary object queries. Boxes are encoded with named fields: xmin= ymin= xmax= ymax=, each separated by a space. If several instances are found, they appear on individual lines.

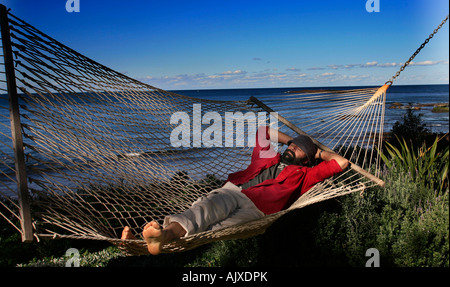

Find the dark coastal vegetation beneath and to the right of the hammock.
xmin=0 ymin=108 xmax=449 ymax=267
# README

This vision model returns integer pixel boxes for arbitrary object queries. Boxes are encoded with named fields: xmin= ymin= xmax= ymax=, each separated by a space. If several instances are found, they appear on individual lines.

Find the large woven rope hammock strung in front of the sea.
xmin=0 ymin=6 xmax=448 ymax=254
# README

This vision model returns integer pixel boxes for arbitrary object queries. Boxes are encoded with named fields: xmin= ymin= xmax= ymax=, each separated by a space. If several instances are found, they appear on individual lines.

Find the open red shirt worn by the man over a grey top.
xmin=228 ymin=126 xmax=342 ymax=214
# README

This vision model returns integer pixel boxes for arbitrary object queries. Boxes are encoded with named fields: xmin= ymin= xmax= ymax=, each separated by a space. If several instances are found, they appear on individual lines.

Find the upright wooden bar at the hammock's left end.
xmin=0 ymin=4 xmax=33 ymax=242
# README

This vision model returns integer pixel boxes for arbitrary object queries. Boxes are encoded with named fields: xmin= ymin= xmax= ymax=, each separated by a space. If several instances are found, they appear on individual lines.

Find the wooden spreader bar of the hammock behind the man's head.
xmin=250 ymin=96 xmax=384 ymax=187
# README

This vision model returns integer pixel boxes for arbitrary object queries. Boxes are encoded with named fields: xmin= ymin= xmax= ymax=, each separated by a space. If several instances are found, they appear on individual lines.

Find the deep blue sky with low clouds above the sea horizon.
xmin=0 ymin=0 xmax=450 ymax=90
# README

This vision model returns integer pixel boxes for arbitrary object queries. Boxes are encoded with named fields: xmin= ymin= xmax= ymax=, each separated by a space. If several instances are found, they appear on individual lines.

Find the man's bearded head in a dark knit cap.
xmin=281 ymin=135 xmax=317 ymax=165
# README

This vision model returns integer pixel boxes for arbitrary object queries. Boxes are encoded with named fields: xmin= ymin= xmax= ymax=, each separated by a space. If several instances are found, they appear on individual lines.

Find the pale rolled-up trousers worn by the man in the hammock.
xmin=163 ymin=182 xmax=264 ymax=237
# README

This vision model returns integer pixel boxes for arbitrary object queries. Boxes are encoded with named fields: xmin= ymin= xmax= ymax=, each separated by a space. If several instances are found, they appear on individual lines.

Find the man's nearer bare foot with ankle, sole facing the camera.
xmin=142 ymin=221 xmax=186 ymax=255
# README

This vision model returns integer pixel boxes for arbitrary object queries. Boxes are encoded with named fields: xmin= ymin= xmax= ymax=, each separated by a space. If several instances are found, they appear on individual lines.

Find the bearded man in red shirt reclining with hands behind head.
xmin=122 ymin=126 xmax=349 ymax=255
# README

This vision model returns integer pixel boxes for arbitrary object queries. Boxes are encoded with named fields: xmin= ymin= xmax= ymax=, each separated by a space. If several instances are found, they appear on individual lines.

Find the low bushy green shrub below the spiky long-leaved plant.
xmin=315 ymin=168 xmax=449 ymax=266
